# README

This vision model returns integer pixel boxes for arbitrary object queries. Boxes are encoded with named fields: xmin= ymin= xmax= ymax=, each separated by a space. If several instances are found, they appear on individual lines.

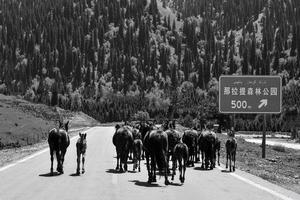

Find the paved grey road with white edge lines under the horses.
xmin=0 ymin=127 xmax=300 ymax=200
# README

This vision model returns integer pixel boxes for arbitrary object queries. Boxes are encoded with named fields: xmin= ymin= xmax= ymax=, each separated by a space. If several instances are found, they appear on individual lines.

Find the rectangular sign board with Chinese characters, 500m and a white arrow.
xmin=219 ymin=76 xmax=282 ymax=113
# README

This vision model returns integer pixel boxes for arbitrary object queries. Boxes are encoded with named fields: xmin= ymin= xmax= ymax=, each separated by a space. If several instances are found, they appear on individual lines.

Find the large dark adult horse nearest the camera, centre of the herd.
xmin=144 ymin=129 xmax=170 ymax=185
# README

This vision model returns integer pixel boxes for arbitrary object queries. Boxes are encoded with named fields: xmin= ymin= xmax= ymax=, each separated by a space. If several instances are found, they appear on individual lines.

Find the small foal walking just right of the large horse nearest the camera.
xmin=172 ymin=142 xmax=189 ymax=183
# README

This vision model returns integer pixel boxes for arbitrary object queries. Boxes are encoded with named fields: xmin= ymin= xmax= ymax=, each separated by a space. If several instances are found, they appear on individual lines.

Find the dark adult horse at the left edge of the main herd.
xmin=112 ymin=125 xmax=133 ymax=172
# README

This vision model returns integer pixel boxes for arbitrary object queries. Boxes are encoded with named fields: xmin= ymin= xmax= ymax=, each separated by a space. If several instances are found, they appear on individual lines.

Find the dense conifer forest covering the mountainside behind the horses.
xmin=0 ymin=0 xmax=300 ymax=131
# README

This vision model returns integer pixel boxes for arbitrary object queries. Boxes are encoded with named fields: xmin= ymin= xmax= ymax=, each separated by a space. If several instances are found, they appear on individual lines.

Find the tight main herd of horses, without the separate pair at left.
xmin=112 ymin=122 xmax=237 ymax=185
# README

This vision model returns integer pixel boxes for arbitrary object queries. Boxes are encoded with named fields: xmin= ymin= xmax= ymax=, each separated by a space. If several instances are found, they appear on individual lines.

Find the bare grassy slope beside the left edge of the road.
xmin=0 ymin=95 xmax=98 ymax=149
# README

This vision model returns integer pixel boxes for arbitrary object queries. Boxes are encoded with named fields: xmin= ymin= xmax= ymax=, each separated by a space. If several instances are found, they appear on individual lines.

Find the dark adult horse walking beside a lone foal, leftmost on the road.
xmin=48 ymin=121 xmax=70 ymax=174
